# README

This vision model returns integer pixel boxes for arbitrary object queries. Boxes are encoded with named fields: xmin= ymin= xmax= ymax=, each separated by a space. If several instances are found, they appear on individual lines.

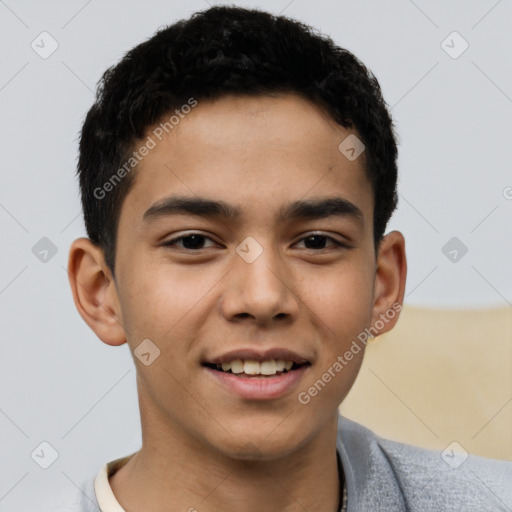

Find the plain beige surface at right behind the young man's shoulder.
xmin=340 ymin=305 xmax=512 ymax=460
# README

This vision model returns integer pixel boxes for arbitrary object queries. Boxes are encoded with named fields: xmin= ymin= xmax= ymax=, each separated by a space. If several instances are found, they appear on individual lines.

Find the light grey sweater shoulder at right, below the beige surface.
xmin=338 ymin=415 xmax=512 ymax=511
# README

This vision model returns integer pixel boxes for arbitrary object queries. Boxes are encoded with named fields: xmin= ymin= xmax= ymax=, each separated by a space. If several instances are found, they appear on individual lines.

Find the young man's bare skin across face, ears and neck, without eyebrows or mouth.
xmin=68 ymin=94 xmax=406 ymax=512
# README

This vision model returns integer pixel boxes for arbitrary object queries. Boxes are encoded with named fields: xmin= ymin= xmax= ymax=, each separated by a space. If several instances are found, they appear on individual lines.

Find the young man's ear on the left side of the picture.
xmin=68 ymin=238 xmax=126 ymax=345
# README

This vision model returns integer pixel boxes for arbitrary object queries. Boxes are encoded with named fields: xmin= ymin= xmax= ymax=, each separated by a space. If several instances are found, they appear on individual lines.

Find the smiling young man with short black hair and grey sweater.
xmin=67 ymin=7 xmax=512 ymax=512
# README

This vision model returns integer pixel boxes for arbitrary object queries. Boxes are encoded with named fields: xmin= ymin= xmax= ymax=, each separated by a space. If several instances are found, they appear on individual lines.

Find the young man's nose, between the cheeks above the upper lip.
xmin=221 ymin=242 xmax=299 ymax=325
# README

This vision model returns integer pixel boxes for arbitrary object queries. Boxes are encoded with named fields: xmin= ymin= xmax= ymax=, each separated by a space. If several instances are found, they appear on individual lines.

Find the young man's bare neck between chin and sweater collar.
xmin=110 ymin=396 xmax=340 ymax=512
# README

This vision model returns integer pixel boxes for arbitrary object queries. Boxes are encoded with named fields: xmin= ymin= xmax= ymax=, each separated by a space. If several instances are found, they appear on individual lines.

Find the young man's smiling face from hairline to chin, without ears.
xmin=74 ymin=95 xmax=406 ymax=459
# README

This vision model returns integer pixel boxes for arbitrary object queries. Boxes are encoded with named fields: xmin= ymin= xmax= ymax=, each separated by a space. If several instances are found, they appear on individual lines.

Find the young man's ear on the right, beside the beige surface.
xmin=370 ymin=231 xmax=407 ymax=336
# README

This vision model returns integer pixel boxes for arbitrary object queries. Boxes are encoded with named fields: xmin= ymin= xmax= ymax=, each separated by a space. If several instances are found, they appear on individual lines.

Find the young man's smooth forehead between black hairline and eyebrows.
xmin=117 ymin=94 xmax=372 ymax=230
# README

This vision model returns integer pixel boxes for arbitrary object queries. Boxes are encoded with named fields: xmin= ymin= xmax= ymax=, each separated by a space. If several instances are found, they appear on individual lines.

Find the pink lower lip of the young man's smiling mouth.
xmin=205 ymin=365 xmax=309 ymax=400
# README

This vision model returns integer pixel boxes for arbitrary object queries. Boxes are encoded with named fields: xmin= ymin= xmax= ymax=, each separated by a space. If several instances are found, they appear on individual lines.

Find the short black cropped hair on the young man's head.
xmin=77 ymin=5 xmax=397 ymax=276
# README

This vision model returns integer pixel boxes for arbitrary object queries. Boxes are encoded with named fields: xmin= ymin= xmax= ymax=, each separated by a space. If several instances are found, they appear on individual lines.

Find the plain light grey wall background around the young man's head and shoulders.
xmin=0 ymin=0 xmax=512 ymax=512
